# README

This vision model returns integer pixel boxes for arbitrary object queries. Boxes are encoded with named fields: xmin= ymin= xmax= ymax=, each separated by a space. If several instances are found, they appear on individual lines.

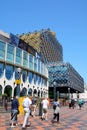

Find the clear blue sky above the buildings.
xmin=0 ymin=0 xmax=87 ymax=83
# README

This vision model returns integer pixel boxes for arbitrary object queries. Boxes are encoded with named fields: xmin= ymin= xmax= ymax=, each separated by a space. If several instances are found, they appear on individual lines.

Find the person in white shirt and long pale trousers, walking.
xmin=22 ymin=95 xmax=32 ymax=129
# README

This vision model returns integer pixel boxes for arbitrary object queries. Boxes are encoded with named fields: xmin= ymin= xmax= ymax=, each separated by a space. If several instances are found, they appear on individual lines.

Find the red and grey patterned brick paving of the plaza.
xmin=0 ymin=104 xmax=87 ymax=130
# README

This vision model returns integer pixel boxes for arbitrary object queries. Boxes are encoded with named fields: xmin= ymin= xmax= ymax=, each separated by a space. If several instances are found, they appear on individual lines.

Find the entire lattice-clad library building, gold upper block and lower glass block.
xmin=19 ymin=29 xmax=84 ymax=99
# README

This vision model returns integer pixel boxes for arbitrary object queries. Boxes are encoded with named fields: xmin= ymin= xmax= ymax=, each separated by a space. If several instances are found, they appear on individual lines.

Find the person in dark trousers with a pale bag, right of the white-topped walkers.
xmin=52 ymin=98 xmax=60 ymax=123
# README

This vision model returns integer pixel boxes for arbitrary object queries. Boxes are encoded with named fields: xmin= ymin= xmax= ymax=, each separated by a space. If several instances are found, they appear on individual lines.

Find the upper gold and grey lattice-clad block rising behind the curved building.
xmin=19 ymin=29 xmax=63 ymax=63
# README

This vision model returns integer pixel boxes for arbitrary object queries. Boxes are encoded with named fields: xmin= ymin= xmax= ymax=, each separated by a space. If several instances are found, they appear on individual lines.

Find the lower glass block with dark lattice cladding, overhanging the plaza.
xmin=48 ymin=62 xmax=84 ymax=97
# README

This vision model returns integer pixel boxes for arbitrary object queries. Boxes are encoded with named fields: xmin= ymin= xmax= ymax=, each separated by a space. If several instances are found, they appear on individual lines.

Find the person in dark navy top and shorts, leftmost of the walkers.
xmin=11 ymin=97 xmax=19 ymax=127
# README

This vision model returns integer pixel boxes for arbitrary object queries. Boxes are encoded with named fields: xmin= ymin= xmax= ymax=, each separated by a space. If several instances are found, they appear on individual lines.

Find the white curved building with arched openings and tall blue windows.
xmin=0 ymin=31 xmax=48 ymax=97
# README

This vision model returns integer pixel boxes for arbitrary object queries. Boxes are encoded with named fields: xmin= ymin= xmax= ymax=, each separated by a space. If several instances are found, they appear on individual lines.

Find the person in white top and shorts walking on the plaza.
xmin=41 ymin=98 xmax=49 ymax=120
